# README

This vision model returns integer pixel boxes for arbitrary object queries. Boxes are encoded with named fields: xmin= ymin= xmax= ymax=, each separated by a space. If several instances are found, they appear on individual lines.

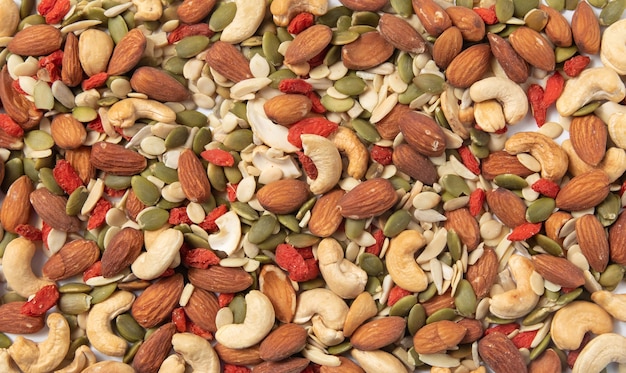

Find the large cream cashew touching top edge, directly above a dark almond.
xmin=220 ymin=0 xmax=266 ymax=44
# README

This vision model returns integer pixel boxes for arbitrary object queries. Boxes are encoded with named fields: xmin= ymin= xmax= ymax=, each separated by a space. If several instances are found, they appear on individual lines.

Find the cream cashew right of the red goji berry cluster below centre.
xmin=317 ymin=238 xmax=367 ymax=299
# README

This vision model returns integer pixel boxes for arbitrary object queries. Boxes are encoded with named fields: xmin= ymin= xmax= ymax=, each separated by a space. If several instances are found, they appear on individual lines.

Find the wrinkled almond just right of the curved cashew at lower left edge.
xmin=42 ymin=238 xmax=100 ymax=281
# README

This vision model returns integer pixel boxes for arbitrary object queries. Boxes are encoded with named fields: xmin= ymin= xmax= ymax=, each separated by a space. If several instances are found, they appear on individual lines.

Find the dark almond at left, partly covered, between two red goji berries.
xmin=30 ymin=188 xmax=81 ymax=233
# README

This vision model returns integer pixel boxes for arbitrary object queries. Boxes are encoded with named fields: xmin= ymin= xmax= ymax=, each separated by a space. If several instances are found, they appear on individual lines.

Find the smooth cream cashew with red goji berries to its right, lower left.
xmin=130 ymin=228 xmax=184 ymax=280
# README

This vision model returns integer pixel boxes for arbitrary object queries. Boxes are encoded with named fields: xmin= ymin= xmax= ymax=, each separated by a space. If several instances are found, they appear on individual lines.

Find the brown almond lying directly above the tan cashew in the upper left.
xmin=130 ymin=66 xmax=189 ymax=102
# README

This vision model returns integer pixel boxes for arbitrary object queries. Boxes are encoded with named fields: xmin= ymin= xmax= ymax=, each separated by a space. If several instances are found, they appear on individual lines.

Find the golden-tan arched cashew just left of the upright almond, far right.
xmin=504 ymin=132 xmax=569 ymax=182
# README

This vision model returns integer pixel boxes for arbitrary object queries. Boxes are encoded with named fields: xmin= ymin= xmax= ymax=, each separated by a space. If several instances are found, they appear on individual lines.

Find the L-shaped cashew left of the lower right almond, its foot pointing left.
xmin=489 ymin=254 xmax=539 ymax=319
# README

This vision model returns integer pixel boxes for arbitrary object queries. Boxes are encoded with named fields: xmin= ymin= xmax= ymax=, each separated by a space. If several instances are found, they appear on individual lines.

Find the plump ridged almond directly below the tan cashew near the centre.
xmin=337 ymin=178 xmax=398 ymax=219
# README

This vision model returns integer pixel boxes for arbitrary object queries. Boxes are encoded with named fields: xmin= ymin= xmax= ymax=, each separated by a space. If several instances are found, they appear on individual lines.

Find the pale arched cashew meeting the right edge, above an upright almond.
xmin=556 ymin=67 xmax=626 ymax=117
